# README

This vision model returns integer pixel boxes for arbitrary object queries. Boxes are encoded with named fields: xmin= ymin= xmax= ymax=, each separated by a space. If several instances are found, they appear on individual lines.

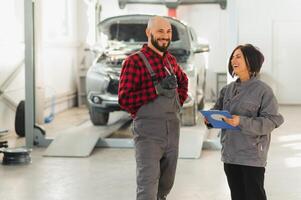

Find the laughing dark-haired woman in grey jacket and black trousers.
xmin=210 ymin=44 xmax=283 ymax=200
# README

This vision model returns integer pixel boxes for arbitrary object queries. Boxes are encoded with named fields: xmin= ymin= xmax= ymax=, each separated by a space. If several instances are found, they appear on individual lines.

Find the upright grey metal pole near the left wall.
xmin=24 ymin=0 xmax=35 ymax=148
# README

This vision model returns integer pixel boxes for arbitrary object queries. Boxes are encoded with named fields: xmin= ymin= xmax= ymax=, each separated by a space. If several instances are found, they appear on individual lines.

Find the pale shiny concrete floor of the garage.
xmin=0 ymin=106 xmax=301 ymax=200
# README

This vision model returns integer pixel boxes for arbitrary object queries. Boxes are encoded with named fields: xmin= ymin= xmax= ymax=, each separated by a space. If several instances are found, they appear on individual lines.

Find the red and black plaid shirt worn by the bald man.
xmin=118 ymin=44 xmax=188 ymax=117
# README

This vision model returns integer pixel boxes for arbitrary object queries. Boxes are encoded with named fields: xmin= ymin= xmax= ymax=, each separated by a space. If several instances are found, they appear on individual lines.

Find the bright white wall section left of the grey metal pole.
xmin=0 ymin=0 xmax=25 ymax=129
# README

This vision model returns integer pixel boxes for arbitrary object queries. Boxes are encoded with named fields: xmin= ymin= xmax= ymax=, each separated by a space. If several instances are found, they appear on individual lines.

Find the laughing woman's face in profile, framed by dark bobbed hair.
xmin=231 ymin=49 xmax=250 ymax=79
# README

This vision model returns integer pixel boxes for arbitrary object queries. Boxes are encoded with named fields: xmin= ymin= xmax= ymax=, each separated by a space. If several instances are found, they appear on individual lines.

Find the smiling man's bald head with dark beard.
xmin=148 ymin=18 xmax=172 ymax=52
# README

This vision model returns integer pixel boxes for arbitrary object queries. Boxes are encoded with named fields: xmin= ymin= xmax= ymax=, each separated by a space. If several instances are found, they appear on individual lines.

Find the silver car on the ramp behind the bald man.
xmin=86 ymin=15 xmax=209 ymax=125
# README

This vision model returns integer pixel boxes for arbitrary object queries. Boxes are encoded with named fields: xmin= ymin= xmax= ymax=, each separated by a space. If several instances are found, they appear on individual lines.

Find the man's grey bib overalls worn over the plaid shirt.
xmin=132 ymin=52 xmax=180 ymax=200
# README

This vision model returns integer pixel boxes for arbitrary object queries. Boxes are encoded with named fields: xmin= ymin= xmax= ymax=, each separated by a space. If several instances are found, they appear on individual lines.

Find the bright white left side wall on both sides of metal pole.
xmin=0 ymin=0 xmax=84 ymax=130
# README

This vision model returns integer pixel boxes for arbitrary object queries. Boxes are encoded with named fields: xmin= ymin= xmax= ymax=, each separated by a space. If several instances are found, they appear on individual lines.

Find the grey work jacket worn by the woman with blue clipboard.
xmin=213 ymin=77 xmax=283 ymax=167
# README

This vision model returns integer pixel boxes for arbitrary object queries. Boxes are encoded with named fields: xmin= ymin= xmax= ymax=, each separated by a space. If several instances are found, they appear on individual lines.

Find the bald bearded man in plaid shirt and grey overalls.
xmin=118 ymin=16 xmax=188 ymax=200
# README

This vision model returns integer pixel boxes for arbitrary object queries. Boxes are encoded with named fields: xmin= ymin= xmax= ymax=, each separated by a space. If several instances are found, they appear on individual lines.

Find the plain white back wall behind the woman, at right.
xmin=238 ymin=0 xmax=301 ymax=104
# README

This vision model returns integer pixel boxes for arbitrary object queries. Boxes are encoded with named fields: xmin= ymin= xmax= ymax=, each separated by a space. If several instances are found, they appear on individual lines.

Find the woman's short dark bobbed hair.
xmin=228 ymin=44 xmax=264 ymax=77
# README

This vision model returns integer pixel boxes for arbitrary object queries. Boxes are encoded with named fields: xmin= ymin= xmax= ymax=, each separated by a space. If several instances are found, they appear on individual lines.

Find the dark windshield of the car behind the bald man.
xmin=102 ymin=23 xmax=179 ymax=42
